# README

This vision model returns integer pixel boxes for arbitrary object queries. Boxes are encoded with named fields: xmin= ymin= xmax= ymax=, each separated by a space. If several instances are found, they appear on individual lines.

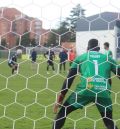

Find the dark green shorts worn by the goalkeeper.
xmin=67 ymin=93 xmax=112 ymax=112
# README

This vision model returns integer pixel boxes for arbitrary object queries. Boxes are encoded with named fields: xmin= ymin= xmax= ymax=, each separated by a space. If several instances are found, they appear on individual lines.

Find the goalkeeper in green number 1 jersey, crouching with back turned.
xmin=52 ymin=39 xmax=120 ymax=129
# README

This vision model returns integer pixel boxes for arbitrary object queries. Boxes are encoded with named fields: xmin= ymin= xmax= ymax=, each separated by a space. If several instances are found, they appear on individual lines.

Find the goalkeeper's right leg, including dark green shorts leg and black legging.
xmin=96 ymin=98 xmax=118 ymax=129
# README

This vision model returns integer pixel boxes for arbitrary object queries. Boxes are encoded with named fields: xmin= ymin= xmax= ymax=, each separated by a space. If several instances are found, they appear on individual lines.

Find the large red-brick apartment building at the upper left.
xmin=0 ymin=8 xmax=48 ymax=48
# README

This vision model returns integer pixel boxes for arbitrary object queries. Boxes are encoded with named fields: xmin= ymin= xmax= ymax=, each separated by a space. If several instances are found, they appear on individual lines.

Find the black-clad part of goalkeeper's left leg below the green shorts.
xmin=52 ymin=102 xmax=77 ymax=129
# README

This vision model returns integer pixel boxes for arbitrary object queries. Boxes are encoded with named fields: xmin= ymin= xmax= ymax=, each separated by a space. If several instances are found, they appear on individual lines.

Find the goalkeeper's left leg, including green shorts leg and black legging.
xmin=52 ymin=93 xmax=93 ymax=129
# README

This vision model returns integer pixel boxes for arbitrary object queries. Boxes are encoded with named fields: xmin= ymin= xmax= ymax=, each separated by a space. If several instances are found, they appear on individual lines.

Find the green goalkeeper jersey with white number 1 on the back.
xmin=71 ymin=51 xmax=117 ymax=97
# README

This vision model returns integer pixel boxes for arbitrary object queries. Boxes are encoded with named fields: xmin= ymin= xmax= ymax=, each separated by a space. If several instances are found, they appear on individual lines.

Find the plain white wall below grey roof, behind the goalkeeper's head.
xmin=76 ymin=30 xmax=116 ymax=58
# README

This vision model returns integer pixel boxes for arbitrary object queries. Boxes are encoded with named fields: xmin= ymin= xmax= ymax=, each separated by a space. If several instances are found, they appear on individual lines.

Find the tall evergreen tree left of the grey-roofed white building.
xmin=58 ymin=4 xmax=85 ymax=42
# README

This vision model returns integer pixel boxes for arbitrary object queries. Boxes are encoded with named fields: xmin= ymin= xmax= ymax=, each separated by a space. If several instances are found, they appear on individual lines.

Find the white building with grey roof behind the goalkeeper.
xmin=76 ymin=12 xmax=120 ymax=58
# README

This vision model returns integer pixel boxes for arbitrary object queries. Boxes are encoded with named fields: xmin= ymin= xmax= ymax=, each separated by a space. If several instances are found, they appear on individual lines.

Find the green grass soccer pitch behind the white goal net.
xmin=0 ymin=58 xmax=120 ymax=129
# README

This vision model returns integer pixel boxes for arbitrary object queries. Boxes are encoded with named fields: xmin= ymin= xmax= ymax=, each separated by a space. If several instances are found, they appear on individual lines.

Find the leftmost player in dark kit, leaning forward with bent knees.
xmin=8 ymin=54 xmax=18 ymax=74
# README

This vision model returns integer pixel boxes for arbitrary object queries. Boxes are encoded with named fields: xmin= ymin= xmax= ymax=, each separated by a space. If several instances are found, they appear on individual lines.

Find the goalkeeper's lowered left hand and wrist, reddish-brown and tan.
xmin=54 ymin=93 xmax=65 ymax=114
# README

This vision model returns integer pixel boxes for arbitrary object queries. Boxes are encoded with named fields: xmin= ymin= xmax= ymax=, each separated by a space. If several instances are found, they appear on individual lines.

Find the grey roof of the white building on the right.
xmin=76 ymin=12 xmax=120 ymax=31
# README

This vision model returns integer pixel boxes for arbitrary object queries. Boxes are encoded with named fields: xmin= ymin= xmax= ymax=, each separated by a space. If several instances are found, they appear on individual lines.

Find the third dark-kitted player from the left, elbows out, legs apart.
xmin=44 ymin=50 xmax=55 ymax=74
